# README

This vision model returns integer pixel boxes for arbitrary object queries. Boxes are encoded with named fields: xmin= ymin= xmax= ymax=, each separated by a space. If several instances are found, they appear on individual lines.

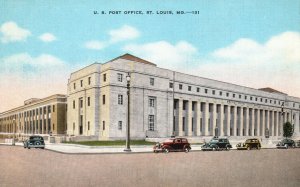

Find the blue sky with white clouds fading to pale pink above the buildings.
xmin=0 ymin=0 xmax=300 ymax=111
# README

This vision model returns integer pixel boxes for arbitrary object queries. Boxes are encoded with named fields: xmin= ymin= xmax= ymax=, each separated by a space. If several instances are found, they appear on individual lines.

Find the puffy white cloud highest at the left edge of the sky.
xmin=0 ymin=22 xmax=31 ymax=43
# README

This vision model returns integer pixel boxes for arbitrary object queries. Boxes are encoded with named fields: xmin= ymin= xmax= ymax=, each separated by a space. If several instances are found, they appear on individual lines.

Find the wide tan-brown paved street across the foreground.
xmin=0 ymin=145 xmax=300 ymax=187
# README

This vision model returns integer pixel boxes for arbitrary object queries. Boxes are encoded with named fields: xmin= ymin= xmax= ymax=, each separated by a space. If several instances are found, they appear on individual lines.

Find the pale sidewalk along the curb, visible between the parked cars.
xmin=0 ymin=142 xmax=276 ymax=154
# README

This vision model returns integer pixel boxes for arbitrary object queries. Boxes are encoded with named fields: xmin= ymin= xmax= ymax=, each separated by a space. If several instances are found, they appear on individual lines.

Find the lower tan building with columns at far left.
xmin=0 ymin=94 xmax=67 ymax=137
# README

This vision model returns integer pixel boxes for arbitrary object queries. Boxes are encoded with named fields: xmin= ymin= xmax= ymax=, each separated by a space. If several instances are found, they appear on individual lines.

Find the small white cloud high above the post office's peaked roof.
xmin=109 ymin=25 xmax=140 ymax=43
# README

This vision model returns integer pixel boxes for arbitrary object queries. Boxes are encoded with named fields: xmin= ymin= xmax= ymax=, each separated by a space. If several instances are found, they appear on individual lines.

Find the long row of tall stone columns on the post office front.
xmin=173 ymin=99 xmax=290 ymax=136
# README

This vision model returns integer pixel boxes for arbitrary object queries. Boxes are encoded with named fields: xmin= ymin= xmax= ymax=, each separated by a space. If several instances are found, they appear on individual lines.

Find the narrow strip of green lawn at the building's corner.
xmin=64 ymin=140 xmax=155 ymax=146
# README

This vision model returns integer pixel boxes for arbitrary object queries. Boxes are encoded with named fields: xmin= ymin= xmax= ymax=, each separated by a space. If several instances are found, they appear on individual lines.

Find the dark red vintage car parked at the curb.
xmin=153 ymin=138 xmax=191 ymax=153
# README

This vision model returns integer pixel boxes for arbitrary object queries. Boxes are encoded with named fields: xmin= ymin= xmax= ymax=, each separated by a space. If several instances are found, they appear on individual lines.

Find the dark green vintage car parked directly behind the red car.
xmin=201 ymin=137 xmax=232 ymax=151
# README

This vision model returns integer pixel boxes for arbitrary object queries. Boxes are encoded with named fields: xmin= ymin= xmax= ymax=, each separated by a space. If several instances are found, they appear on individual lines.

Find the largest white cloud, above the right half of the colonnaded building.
xmin=192 ymin=32 xmax=300 ymax=97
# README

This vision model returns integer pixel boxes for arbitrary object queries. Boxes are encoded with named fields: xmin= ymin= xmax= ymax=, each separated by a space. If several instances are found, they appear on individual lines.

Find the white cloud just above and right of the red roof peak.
xmin=123 ymin=41 xmax=198 ymax=69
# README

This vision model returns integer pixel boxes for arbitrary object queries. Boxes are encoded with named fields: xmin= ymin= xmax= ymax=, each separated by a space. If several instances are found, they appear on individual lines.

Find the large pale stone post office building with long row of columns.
xmin=67 ymin=54 xmax=300 ymax=140
